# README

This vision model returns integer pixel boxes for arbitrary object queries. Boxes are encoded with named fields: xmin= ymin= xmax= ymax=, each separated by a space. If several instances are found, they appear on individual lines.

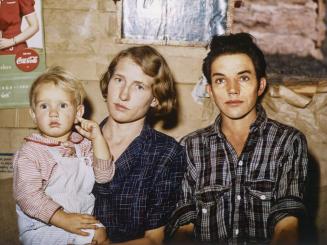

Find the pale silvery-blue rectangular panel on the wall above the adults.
xmin=118 ymin=0 xmax=235 ymax=46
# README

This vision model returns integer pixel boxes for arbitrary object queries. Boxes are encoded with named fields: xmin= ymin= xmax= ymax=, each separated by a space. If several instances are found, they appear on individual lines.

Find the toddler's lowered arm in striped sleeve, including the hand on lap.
xmin=13 ymin=145 xmax=98 ymax=235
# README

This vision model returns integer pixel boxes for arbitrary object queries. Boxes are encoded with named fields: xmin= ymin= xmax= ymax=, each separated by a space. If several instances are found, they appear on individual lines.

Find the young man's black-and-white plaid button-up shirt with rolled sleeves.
xmin=167 ymin=105 xmax=308 ymax=243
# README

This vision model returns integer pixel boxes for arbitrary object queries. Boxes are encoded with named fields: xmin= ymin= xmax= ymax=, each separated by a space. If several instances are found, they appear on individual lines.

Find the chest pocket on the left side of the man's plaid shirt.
xmin=195 ymin=185 xmax=231 ymax=241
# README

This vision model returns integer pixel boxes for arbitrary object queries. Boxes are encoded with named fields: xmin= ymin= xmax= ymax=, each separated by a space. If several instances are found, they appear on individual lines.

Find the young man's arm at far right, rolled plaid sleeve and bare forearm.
xmin=268 ymin=132 xmax=308 ymax=244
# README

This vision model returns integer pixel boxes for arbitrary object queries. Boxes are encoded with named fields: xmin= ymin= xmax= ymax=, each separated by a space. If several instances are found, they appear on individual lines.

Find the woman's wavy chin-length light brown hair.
xmin=100 ymin=45 xmax=177 ymax=115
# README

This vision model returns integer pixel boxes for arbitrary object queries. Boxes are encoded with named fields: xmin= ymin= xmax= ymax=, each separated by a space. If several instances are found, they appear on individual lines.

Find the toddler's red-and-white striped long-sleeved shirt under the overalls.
xmin=13 ymin=133 xmax=115 ymax=223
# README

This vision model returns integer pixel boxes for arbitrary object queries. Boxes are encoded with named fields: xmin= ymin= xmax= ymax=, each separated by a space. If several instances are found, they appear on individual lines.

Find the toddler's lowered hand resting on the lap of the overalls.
xmin=50 ymin=209 xmax=99 ymax=236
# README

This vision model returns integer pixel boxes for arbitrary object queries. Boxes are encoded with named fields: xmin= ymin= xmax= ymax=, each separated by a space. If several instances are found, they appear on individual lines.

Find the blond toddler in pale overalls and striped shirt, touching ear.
xmin=13 ymin=67 xmax=115 ymax=245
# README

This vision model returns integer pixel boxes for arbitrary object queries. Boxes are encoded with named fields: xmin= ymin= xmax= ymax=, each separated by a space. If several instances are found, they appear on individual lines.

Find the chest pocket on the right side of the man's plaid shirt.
xmin=246 ymin=179 xmax=275 ymax=239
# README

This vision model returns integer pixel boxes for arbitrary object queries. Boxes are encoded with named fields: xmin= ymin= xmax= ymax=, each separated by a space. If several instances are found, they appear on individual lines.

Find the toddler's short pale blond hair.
xmin=29 ymin=66 xmax=85 ymax=109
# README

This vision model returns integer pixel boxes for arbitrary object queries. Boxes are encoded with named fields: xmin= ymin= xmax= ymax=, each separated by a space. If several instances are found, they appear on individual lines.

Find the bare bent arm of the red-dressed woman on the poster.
xmin=0 ymin=12 xmax=39 ymax=49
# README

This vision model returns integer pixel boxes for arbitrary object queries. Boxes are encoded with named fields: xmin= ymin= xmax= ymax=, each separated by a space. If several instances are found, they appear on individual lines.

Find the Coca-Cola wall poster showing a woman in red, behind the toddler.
xmin=0 ymin=0 xmax=46 ymax=109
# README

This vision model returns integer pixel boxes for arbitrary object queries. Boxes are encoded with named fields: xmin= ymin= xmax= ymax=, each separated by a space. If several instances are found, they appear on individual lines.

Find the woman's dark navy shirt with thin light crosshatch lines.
xmin=93 ymin=125 xmax=186 ymax=242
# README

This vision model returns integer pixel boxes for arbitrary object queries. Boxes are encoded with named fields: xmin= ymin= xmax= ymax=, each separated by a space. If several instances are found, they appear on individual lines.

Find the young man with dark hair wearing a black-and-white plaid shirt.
xmin=167 ymin=33 xmax=308 ymax=244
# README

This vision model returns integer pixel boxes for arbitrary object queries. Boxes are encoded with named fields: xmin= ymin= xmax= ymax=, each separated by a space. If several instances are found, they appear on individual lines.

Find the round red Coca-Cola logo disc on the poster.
xmin=15 ymin=48 xmax=40 ymax=72
